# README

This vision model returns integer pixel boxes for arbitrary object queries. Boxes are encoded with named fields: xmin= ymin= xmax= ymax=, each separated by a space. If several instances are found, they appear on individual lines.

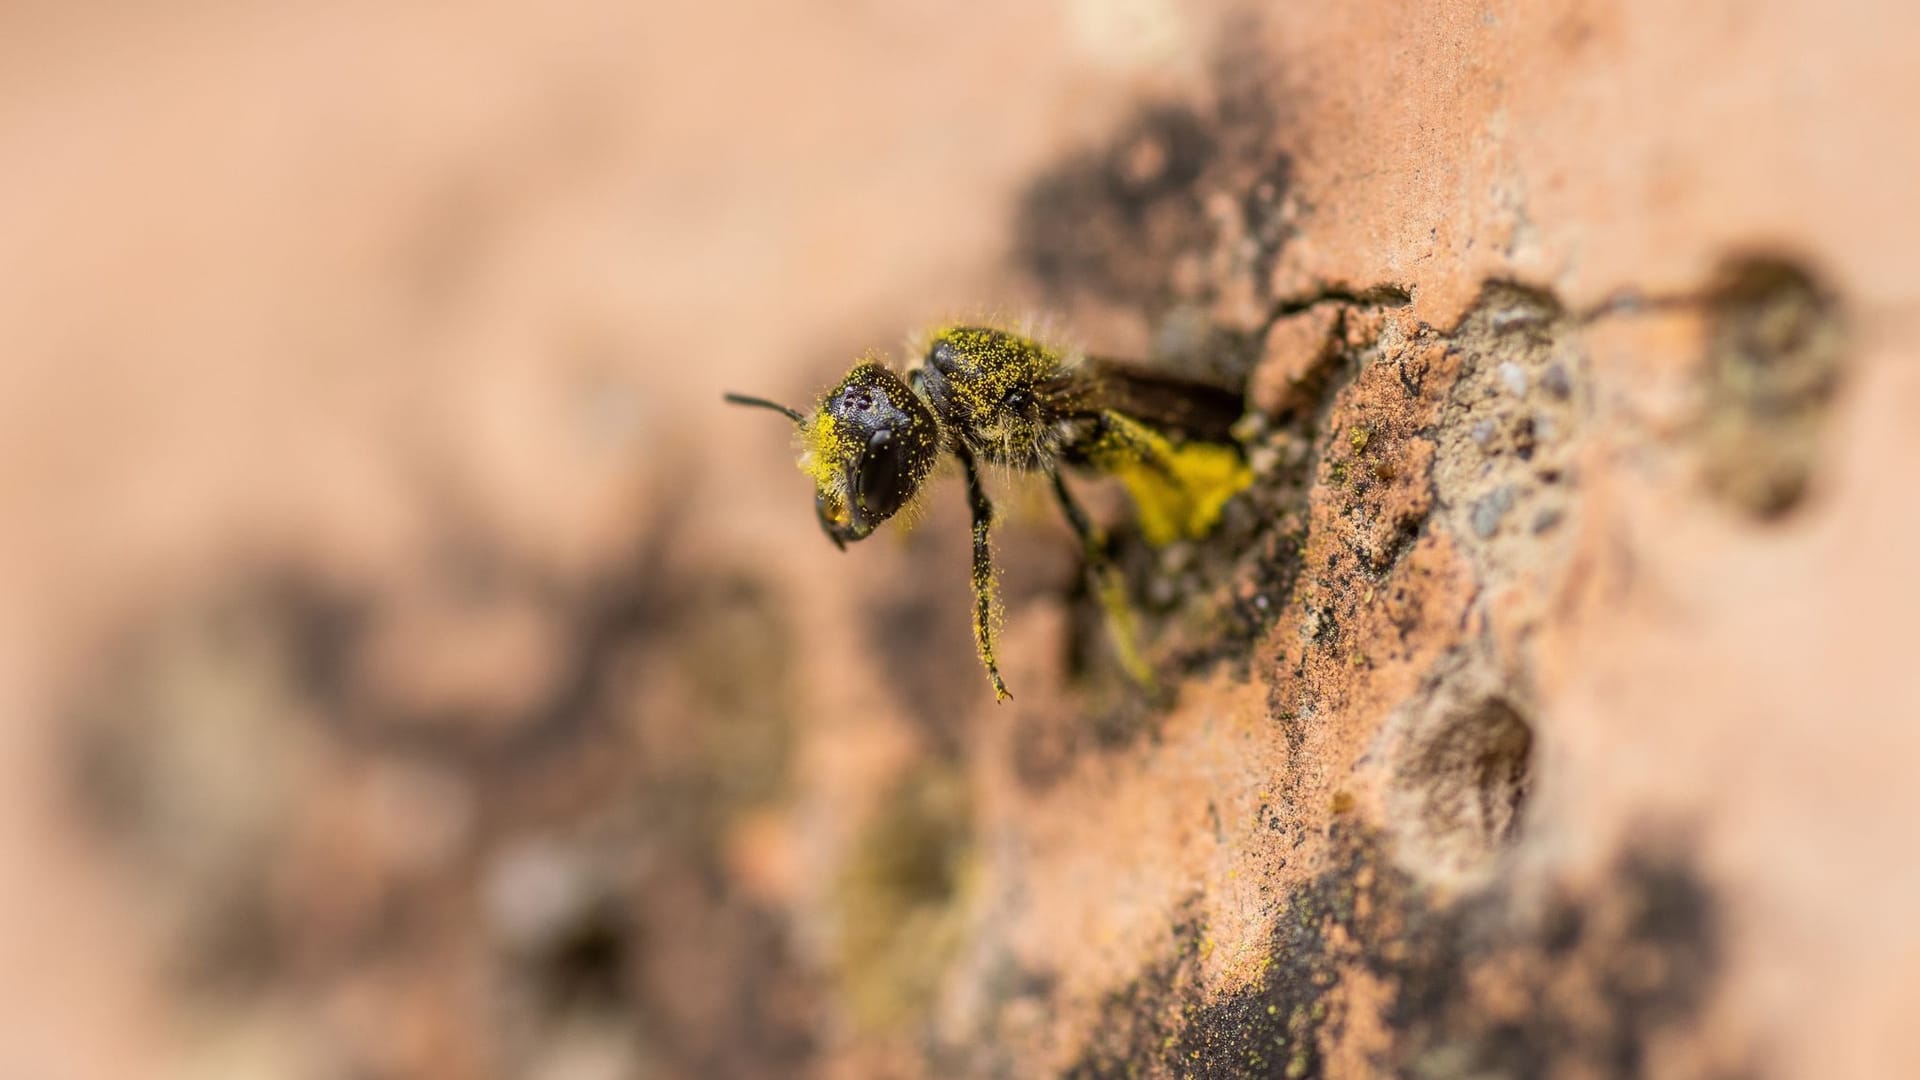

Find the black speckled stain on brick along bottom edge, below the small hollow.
xmin=1068 ymin=830 xmax=1749 ymax=1080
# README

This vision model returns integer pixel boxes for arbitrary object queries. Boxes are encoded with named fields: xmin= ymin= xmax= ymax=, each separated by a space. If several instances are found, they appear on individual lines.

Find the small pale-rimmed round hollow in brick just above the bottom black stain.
xmin=1386 ymin=696 xmax=1534 ymax=884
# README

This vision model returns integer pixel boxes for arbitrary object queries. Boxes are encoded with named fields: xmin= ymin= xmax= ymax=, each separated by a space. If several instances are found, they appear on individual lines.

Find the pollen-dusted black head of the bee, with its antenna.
xmin=728 ymin=363 xmax=941 ymax=548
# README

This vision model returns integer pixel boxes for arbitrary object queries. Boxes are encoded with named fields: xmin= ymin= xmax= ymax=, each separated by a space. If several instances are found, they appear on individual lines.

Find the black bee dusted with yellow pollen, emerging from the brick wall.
xmin=726 ymin=325 xmax=1252 ymax=701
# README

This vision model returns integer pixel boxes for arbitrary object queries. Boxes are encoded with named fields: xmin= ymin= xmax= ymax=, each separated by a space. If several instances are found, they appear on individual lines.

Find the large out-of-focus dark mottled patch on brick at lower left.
xmin=67 ymin=503 xmax=816 ymax=1076
